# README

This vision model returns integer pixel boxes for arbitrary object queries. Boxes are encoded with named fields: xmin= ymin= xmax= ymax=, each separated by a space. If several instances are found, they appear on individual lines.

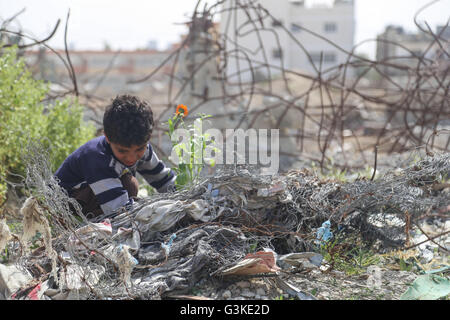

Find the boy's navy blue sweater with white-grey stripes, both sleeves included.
xmin=55 ymin=136 xmax=176 ymax=214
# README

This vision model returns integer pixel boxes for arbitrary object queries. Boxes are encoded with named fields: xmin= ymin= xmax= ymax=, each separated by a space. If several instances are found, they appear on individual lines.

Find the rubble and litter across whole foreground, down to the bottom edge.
xmin=0 ymin=150 xmax=450 ymax=300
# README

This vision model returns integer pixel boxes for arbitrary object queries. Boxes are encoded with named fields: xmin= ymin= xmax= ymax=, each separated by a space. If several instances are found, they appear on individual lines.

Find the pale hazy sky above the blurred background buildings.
xmin=0 ymin=0 xmax=450 ymax=55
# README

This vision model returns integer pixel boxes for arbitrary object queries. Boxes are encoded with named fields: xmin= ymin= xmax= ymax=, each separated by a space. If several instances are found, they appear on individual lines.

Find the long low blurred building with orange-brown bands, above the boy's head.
xmin=25 ymin=48 xmax=169 ymax=99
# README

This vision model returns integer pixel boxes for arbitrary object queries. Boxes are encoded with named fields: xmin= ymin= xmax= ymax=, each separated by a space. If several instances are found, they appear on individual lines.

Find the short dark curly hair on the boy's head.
xmin=103 ymin=95 xmax=153 ymax=147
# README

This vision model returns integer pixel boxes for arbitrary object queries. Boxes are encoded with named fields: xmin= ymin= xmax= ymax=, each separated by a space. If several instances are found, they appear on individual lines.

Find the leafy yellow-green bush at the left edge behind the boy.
xmin=0 ymin=46 xmax=95 ymax=205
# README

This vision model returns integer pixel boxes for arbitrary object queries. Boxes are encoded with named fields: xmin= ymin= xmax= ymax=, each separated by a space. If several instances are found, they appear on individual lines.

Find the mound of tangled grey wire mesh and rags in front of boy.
xmin=8 ymin=143 xmax=444 ymax=299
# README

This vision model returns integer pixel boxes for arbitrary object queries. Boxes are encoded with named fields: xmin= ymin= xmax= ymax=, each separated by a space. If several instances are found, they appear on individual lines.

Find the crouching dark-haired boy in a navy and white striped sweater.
xmin=55 ymin=95 xmax=176 ymax=216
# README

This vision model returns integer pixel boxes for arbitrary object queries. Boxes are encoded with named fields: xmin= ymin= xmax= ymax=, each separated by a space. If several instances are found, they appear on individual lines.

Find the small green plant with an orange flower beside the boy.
xmin=167 ymin=104 xmax=219 ymax=187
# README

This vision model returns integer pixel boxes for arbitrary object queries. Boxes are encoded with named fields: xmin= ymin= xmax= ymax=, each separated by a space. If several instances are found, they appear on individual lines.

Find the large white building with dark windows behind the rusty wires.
xmin=220 ymin=0 xmax=355 ymax=80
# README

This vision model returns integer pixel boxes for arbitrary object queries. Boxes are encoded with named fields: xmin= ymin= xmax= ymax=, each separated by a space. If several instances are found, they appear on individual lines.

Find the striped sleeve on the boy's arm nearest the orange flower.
xmin=137 ymin=145 xmax=176 ymax=193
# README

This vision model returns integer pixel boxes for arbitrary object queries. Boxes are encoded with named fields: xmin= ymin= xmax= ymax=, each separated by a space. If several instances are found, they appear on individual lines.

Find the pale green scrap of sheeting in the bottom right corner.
xmin=400 ymin=274 xmax=450 ymax=300
